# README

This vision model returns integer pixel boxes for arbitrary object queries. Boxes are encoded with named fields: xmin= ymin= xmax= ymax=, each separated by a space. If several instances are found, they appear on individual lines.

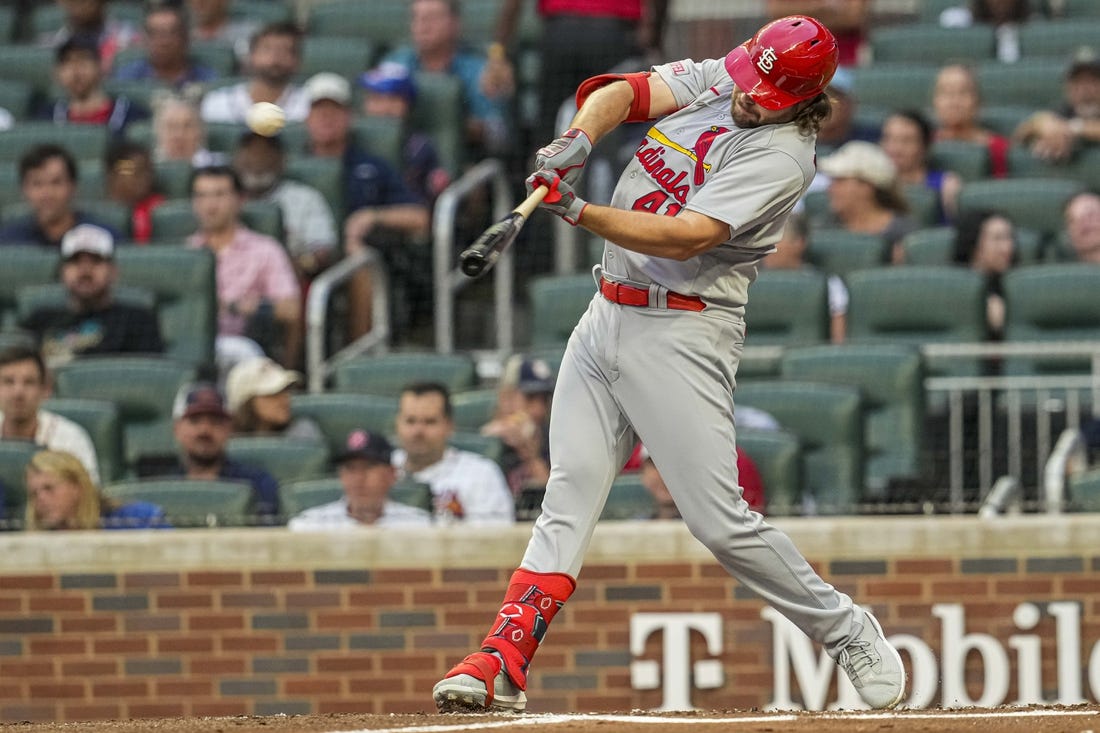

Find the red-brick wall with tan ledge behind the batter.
xmin=0 ymin=516 xmax=1100 ymax=721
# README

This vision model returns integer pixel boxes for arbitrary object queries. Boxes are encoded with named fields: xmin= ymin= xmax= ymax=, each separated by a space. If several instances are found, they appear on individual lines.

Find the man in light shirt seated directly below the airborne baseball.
xmin=233 ymin=132 xmax=339 ymax=281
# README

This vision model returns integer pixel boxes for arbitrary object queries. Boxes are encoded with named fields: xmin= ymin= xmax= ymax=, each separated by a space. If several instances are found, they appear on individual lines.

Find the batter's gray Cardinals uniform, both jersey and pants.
xmin=520 ymin=55 xmax=862 ymax=656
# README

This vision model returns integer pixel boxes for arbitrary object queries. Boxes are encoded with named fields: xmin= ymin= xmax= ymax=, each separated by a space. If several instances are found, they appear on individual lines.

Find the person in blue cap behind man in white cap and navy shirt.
xmin=356 ymin=63 xmax=451 ymax=205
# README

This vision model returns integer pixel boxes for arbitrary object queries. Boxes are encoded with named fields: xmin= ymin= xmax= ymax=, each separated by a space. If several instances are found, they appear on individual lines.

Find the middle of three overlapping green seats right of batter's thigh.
xmin=735 ymin=380 xmax=864 ymax=514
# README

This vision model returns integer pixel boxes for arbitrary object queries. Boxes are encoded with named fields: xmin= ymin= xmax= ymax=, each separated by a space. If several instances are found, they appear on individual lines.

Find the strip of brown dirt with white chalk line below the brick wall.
xmin=0 ymin=705 xmax=1100 ymax=733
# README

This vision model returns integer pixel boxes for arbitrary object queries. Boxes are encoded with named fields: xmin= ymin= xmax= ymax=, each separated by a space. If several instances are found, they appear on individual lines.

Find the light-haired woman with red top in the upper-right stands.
xmin=932 ymin=64 xmax=1009 ymax=178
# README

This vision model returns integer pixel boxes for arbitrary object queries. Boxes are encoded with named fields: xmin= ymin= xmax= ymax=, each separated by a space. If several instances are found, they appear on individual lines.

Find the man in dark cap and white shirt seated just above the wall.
xmin=286 ymin=429 xmax=431 ymax=530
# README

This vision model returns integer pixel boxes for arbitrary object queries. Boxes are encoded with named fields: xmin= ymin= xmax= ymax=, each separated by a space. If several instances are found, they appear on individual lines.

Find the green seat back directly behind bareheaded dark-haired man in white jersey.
xmin=334 ymin=352 xmax=477 ymax=397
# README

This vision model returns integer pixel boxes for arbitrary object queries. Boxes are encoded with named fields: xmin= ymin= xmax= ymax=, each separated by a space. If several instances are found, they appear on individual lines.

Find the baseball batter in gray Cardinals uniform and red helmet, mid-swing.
xmin=433 ymin=15 xmax=905 ymax=711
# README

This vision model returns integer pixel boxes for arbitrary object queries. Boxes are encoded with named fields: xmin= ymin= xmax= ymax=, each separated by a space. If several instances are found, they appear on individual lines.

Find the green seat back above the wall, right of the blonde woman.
xmin=103 ymin=479 xmax=252 ymax=527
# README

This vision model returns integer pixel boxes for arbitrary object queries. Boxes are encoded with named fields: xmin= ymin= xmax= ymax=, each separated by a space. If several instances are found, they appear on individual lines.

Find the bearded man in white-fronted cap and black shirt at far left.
xmin=20 ymin=225 xmax=164 ymax=369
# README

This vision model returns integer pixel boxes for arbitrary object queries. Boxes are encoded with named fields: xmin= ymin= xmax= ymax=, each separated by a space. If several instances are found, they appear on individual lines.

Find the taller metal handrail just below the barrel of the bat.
xmin=431 ymin=158 xmax=515 ymax=354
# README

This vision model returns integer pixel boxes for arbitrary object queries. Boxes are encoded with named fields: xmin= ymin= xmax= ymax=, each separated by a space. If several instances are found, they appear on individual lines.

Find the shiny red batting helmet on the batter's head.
xmin=726 ymin=15 xmax=837 ymax=109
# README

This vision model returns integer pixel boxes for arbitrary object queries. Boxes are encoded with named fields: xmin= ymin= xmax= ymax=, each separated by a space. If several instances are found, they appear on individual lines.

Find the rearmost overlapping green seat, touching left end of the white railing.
xmin=781 ymin=343 xmax=924 ymax=500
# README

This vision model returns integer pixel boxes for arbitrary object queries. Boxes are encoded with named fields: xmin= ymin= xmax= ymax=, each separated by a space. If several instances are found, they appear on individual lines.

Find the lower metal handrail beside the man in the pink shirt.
xmin=306 ymin=247 xmax=389 ymax=392
